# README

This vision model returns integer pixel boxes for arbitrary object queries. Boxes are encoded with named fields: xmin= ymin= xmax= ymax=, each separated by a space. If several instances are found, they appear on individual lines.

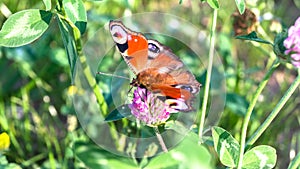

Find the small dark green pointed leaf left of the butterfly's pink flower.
xmin=105 ymin=104 xmax=131 ymax=121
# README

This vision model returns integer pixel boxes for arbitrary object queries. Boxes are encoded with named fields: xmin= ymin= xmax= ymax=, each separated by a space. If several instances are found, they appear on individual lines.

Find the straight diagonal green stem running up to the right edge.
xmin=246 ymin=69 xmax=300 ymax=146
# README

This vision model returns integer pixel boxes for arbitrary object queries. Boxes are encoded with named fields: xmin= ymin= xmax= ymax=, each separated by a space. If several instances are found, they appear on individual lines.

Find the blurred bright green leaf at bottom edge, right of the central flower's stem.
xmin=144 ymin=132 xmax=213 ymax=169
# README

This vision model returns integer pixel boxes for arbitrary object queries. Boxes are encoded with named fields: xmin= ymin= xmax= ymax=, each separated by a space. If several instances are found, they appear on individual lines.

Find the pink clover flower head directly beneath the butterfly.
xmin=129 ymin=87 xmax=178 ymax=126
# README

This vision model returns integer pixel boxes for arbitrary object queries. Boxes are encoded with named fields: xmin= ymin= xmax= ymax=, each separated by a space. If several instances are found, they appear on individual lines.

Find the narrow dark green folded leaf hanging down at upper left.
xmin=57 ymin=16 xmax=78 ymax=80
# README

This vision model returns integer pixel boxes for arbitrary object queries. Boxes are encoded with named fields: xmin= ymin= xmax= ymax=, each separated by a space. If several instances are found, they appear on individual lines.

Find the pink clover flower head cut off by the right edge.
xmin=283 ymin=17 xmax=300 ymax=68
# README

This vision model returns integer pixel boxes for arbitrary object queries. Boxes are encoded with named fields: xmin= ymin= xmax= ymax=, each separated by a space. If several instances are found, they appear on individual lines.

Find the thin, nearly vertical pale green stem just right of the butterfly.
xmin=198 ymin=9 xmax=218 ymax=140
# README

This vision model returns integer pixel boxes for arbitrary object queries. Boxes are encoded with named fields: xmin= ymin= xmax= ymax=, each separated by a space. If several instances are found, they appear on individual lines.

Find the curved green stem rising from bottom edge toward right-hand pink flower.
xmin=237 ymin=59 xmax=280 ymax=169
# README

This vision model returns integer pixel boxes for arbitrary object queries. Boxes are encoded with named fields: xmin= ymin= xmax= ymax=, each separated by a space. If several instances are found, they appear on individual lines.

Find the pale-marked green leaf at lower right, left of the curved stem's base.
xmin=212 ymin=127 xmax=240 ymax=167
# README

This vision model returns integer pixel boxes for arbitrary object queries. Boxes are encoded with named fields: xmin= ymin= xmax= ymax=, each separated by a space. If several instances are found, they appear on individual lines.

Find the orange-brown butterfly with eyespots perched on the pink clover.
xmin=109 ymin=21 xmax=201 ymax=112
